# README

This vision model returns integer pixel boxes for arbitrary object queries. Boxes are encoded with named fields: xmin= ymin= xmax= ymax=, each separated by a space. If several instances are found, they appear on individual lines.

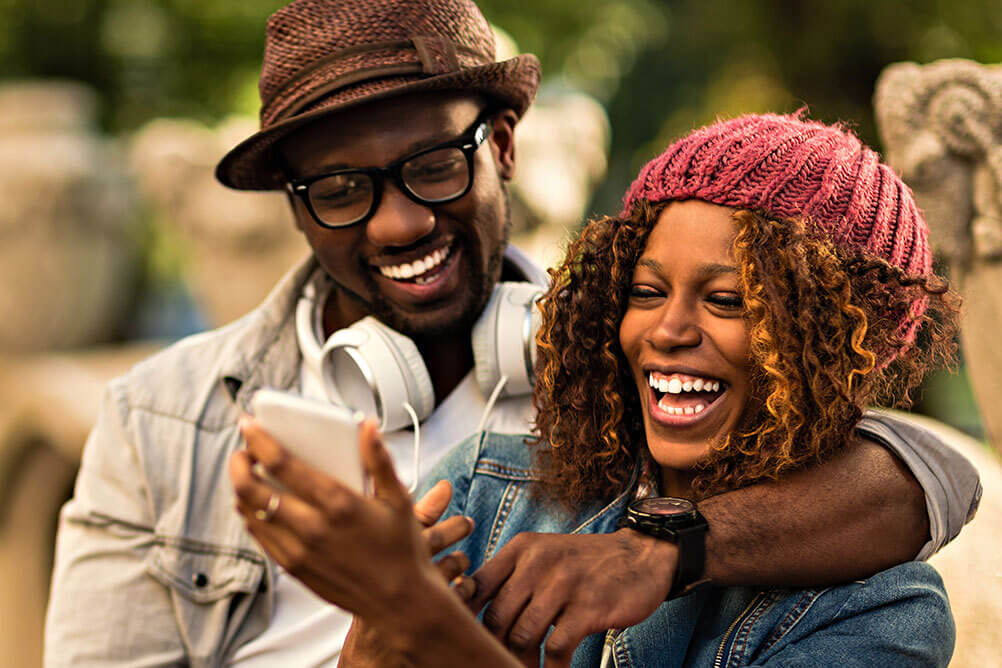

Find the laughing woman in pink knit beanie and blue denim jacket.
xmin=238 ymin=115 xmax=956 ymax=666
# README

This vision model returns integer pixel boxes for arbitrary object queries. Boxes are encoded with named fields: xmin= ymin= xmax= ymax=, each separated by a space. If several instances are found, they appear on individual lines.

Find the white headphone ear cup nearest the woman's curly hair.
xmin=473 ymin=282 xmax=543 ymax=397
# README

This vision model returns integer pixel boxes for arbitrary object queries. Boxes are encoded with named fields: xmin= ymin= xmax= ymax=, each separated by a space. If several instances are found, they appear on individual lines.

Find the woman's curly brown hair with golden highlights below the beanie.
xmin=533 ymin=200 xmax=959 ymax=507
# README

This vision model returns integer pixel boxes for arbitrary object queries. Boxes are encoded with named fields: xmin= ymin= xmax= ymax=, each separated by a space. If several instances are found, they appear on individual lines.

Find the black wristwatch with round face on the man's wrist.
xmin=622 ymin=497 xmax=709 ymax=598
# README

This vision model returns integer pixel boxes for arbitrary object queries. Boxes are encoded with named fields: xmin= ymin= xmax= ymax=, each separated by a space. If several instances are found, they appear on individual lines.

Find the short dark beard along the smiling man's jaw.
xmin=335 ymin=196 xmax=511 ymax=340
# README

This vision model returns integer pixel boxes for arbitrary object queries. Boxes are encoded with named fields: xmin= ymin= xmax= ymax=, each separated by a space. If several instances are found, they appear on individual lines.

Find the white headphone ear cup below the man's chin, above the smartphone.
xmin=323 ymin=315 xmax=435 ymax=432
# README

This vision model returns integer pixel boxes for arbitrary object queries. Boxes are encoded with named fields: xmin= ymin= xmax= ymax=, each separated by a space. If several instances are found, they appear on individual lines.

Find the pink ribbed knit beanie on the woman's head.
xmin=623 ymin=114 xmax=932 ymax=276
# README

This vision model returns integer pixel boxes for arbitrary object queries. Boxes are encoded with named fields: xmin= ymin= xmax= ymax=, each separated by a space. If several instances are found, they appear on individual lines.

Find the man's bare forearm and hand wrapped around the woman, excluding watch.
xmin=470 ymin=428 xmax=977 ymax=657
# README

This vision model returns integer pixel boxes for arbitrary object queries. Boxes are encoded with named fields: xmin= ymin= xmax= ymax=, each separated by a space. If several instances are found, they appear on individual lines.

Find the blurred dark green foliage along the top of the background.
xmin=0 ymin=0 xmax=1002 ymax=212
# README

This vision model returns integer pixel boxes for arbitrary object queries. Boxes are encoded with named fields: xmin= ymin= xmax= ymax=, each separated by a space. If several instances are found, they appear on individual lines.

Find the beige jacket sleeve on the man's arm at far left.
xmin=45 ymin=383 xmax=185 ymax=668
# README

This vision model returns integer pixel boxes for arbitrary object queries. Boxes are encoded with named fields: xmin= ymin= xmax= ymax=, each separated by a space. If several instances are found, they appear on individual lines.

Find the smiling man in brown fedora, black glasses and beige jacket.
xmin=46 ymin=0 xmax=978 ymax=666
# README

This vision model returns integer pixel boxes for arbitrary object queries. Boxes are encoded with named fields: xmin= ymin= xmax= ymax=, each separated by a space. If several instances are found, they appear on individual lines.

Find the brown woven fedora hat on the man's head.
xmin=215 ymin=0 xmax=540 ymax=190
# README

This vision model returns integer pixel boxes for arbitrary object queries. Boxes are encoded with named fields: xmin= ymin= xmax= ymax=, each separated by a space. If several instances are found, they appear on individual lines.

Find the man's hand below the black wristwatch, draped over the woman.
xmin=468 ymin=529 xmax=678 ymax=666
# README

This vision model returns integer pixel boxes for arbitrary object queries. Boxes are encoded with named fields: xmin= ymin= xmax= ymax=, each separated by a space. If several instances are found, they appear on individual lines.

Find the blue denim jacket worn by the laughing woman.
xmin=429 ymin=433 xmax=954 ymax=668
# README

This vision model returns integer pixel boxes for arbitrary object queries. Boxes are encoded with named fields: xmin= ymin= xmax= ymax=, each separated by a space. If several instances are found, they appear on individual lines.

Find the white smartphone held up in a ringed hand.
xmin=251 ymin=388 xmax=369 ymax=494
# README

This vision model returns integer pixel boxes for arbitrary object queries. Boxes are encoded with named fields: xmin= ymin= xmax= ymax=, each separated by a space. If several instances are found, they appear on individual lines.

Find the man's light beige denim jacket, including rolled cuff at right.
xmin=45 ymin=248 xmax=978 ymax=667
